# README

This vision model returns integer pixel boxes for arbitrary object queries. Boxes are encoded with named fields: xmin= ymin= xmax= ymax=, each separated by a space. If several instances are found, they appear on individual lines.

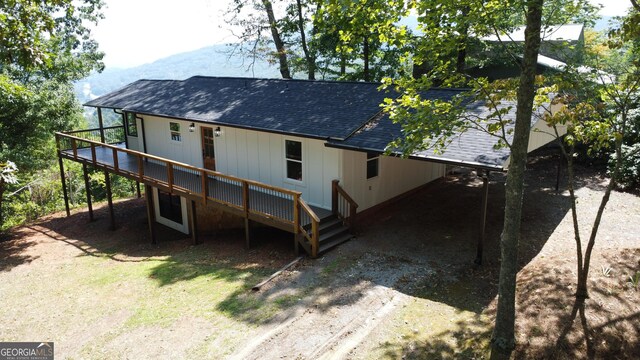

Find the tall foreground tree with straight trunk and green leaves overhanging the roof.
xmin=378 ymin=0 xmax=593 ymax=359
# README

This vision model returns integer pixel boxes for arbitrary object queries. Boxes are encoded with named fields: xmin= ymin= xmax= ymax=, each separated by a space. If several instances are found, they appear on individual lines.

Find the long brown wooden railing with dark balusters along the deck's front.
xmin=56 ymin=129 xmax=320 ymax=256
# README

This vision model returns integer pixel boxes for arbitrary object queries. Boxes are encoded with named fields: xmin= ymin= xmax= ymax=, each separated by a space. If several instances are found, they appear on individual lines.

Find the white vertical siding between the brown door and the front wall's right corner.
xmin=214 ymin=127 xmax=341 ymax=209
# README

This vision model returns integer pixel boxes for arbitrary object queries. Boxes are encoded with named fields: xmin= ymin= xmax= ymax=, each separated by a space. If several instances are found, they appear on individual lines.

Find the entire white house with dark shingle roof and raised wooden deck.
xmin=57 ymin=77 xmax=564 ymax=256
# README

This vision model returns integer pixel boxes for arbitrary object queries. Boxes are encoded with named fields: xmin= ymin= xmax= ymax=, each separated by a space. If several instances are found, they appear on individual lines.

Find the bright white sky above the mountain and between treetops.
xmin=93 ymin=0 xmax=630 ymax=68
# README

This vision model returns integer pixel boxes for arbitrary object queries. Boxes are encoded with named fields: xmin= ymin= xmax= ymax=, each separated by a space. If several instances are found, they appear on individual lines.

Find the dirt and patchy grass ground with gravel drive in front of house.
xmin=0 ymin=150 xmax=640 ymax=359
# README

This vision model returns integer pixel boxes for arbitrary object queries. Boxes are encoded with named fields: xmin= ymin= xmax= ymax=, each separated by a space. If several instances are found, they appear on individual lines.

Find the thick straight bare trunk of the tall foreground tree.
xmin=491 ymin=0 xmax=544 ymax=359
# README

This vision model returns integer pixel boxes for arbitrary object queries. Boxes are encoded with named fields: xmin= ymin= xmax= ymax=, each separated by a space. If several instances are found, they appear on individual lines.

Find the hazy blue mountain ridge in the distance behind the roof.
xmin=75 ymin=45 xmax=280 ymax=103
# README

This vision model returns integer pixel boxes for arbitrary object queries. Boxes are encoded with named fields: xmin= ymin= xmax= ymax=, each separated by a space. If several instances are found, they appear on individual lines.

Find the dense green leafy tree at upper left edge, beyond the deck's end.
xmin=0 ymin=0 xmax=102 ymax=229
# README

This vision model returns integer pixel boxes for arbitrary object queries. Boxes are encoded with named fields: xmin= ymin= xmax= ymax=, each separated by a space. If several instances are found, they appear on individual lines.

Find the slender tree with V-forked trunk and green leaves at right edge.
xmin=546 ymin=2 xmax=640 ymax=303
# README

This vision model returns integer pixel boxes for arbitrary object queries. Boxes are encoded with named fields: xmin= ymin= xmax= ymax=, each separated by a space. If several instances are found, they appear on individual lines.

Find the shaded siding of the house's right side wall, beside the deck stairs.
xmin=340 ymin=150 xmax=446 ymax=212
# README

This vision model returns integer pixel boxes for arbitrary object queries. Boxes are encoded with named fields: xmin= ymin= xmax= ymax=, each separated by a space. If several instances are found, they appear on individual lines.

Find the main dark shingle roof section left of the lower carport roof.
xmin=85 ymin=76 xmax=389 ymax=139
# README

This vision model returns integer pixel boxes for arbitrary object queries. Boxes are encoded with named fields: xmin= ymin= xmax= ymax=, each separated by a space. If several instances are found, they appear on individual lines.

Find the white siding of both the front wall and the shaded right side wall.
xmin=139 ymin=116 xmax=445 ymax=211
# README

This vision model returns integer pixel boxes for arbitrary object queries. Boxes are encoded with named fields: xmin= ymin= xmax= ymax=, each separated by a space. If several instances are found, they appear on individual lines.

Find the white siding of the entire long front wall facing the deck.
xmin=140 ymin=116 xmax=341 ymax=208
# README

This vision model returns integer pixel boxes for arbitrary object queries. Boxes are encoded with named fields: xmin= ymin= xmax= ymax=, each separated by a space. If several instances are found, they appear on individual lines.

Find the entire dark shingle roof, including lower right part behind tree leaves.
xmin=85 ymin=76 xmax=536 ymax=170
